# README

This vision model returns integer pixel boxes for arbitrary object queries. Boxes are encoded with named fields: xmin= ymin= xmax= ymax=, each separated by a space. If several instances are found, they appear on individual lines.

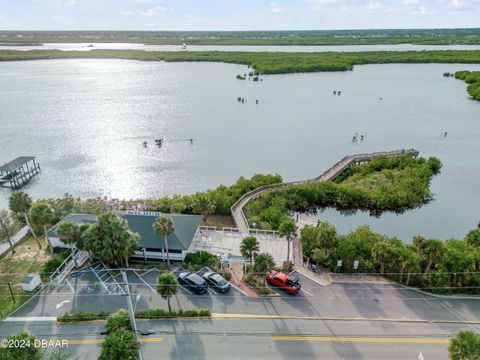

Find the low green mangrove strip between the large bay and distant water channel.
xmin=0 ymin=50 xmax=480 ymax=74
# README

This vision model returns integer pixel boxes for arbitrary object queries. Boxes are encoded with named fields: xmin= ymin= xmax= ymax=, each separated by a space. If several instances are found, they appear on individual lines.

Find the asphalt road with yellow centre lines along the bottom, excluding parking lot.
xmin=0 ymin=318 xmax=480 ymax=360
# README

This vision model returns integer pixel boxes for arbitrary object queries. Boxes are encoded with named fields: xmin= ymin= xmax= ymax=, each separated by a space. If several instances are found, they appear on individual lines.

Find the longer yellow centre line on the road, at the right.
xmin=270 ymin=336 xmax=450 ymax=344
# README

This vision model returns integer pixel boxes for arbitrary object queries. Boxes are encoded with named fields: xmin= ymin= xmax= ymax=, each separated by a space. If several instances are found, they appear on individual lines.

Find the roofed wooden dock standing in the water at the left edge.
xmin=0 ymin=156 xmax=41 ymax=190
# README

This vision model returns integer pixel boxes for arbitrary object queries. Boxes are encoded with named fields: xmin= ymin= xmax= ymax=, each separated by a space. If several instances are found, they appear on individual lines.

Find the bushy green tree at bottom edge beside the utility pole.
xmin=98 ymin=310 xmax=138 ymax=360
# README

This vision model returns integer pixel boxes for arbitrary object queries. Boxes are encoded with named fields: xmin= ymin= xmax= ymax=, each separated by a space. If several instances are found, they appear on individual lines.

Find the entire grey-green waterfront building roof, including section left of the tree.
xmin=48 ymin=211 xmax=202 ymax=251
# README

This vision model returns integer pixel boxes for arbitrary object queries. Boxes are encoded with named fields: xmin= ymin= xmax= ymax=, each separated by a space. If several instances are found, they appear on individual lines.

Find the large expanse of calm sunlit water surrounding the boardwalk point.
xmin=0 ymin=60 xmax=480 ymax=241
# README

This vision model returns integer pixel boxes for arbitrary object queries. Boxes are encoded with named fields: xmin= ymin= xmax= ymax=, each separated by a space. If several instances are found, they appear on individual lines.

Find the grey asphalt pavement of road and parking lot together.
xmin=5 ymin=272 xmax=480 ymax=360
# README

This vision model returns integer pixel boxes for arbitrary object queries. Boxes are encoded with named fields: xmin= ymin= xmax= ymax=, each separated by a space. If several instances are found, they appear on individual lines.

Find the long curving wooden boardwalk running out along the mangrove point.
xmin=230 ymin=149 xmax=418 ymax=234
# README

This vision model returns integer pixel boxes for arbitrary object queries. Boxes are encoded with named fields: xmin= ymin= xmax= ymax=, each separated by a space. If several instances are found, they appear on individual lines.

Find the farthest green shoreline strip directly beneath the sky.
xmin=0 ymin=29 xmax=480 ymax=46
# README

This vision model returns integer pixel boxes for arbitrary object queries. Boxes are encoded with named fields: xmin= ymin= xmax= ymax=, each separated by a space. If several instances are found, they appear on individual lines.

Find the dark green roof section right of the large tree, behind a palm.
xmin=121 ymin=212 xmax=202 ymax=250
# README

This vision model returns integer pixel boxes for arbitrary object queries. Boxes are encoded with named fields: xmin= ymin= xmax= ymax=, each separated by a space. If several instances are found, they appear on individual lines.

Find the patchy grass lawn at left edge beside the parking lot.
xmin=0 ymin=236 xmax=52 ymax=318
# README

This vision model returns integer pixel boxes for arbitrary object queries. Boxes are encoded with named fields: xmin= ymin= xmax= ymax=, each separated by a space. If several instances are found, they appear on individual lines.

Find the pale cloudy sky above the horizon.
xmin=0 ymin=0 xmax=480 ymax=30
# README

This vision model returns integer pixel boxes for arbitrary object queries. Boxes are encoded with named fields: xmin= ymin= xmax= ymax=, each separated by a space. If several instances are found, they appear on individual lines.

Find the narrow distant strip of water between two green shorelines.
xmin=0 ymin=43 xmax=480 ymax=52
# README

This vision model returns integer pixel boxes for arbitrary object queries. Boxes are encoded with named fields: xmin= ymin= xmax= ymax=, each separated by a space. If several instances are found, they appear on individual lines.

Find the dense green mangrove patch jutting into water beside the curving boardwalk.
xmin=245 ymin=156 xmax=441 ymax=229
